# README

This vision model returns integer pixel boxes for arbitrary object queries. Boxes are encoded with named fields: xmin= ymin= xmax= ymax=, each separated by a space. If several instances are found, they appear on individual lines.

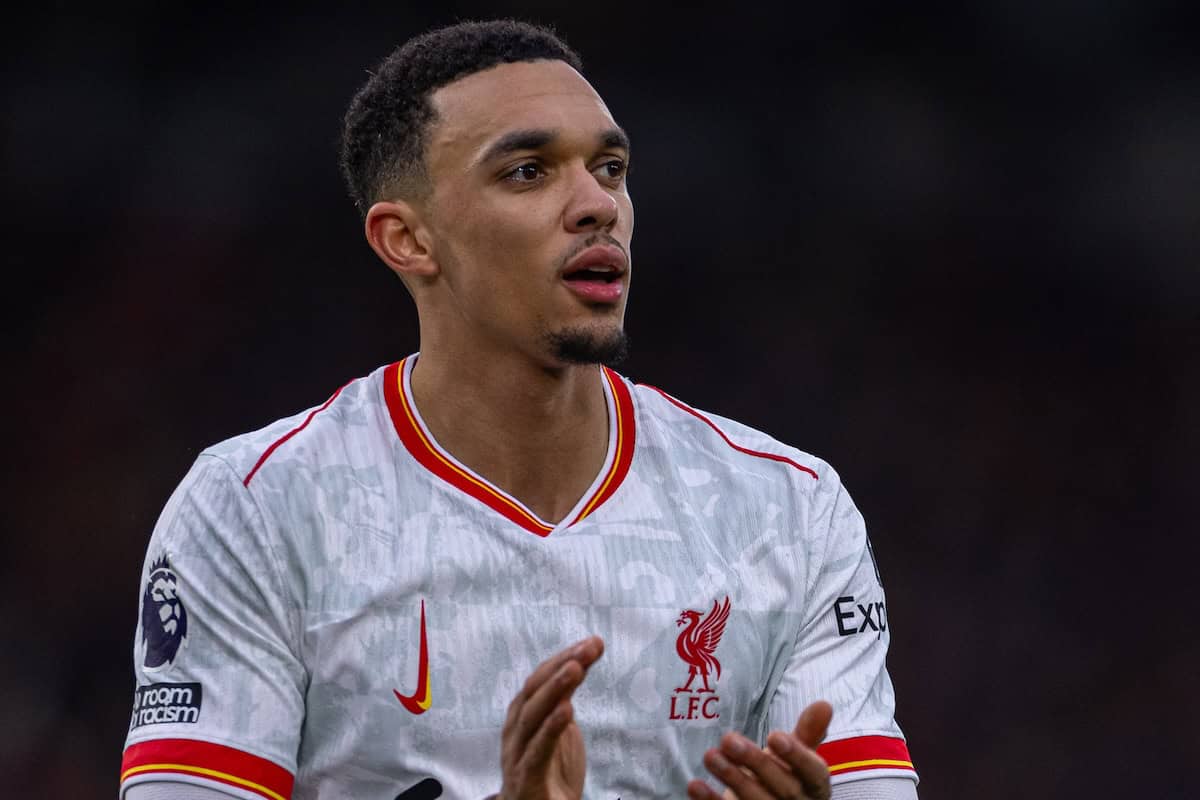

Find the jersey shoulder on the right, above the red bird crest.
xmin=626 ymin=379 xmax=840 ymax=494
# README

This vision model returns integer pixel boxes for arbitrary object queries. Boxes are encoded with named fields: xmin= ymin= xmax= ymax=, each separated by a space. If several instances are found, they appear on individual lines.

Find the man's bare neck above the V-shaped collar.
xmin=412 ymin=347 xmax=608 ymax=524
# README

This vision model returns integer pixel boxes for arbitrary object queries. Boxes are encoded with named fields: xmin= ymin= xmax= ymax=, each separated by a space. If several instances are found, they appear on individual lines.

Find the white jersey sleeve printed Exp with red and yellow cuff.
xmin=768 ymin=470 xmax=917 ymax=786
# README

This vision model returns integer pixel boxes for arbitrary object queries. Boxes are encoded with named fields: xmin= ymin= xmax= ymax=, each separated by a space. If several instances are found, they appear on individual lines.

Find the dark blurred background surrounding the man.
xmin=0 ymin=0 xmax=1200 ymax=800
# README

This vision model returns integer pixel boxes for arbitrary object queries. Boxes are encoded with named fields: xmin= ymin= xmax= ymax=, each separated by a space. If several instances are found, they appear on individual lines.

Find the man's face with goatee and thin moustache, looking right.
xmin=419 ymin=61 xmax=634 ymax=366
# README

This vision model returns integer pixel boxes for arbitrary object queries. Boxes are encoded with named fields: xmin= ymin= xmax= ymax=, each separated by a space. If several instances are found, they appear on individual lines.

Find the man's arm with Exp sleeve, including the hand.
xmin=689 ymin=470 xmax=917 ymax=800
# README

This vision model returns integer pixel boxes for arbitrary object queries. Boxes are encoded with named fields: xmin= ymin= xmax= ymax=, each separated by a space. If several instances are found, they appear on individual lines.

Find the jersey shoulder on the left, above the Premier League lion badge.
xmin=200 ymin=365 xmax=395 ymax=488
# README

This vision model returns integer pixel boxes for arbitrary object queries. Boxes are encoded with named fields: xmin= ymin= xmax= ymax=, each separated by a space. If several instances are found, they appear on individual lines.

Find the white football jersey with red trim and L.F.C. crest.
xmin=121 ymin=356 xmax=916 ymax=800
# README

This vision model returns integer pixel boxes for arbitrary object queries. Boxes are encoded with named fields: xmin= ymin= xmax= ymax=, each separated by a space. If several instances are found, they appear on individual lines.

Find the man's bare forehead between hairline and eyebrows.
xmin=427 ymin=60 xmax=616 ymax=172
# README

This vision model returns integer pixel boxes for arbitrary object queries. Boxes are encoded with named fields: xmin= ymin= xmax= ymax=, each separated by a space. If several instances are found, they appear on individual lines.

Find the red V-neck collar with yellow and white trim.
xmin=384 ymin=354 xmax=635 ymax=536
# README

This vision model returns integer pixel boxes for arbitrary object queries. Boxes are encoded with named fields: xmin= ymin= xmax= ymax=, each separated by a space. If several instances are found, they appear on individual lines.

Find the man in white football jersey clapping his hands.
xmin=122 ymin=22 xmax=916 ymax=800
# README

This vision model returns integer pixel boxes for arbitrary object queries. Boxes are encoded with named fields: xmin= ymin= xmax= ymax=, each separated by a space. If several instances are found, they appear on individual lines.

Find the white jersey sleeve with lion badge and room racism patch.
xmin=121 ymin=455 xmax=306 ymax=800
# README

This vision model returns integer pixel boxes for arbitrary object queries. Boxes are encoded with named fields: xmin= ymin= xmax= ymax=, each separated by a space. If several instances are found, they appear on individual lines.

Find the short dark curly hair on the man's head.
xmin=340 ymin=19 xmax=582 ymax=216
